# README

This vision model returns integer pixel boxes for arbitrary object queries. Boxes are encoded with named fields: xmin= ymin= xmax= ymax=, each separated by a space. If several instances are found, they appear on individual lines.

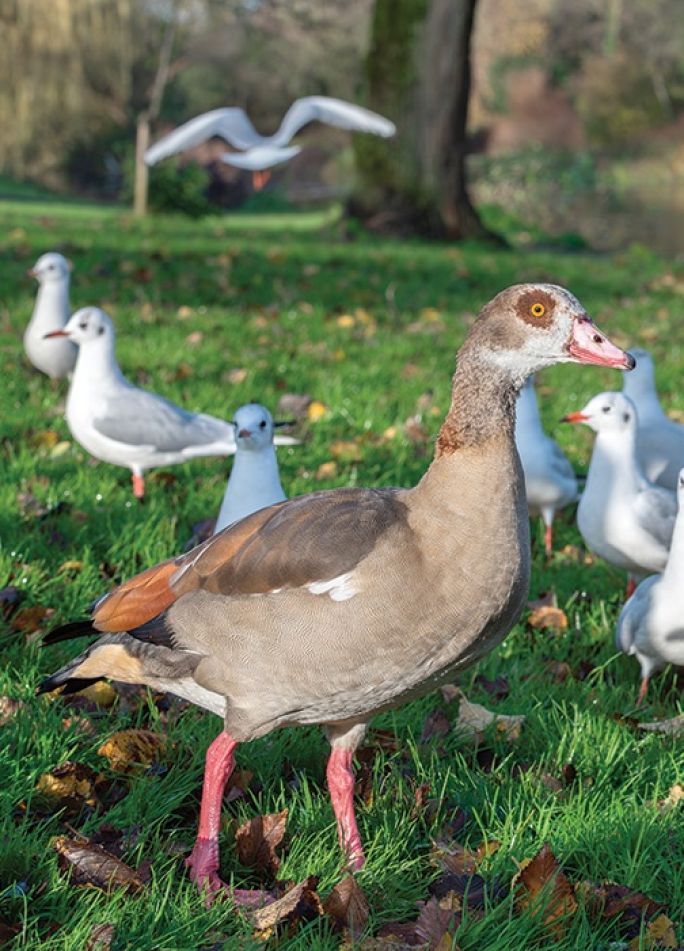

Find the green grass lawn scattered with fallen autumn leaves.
xmin=0 ymin=200 xmax=684 ymax=951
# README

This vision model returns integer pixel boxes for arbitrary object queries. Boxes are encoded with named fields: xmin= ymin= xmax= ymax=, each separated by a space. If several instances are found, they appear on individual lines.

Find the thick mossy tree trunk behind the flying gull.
xmin=349 ymin=0 xmax=500 ymax=240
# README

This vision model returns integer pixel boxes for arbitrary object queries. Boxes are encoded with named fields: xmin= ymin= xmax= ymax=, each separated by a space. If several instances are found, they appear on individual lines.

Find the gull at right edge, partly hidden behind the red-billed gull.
xmin=622 ymin=350 xmax=684 ymax=490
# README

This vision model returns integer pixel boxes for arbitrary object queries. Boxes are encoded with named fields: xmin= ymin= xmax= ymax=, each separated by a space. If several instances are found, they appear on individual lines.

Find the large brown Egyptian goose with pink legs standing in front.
xmin=39 ymin=284 xmax=633 ymax=895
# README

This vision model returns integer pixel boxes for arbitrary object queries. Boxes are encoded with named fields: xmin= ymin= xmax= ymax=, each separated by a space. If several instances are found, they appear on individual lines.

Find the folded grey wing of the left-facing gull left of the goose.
xmin=93 ymin=387 xmax=234 ymax=452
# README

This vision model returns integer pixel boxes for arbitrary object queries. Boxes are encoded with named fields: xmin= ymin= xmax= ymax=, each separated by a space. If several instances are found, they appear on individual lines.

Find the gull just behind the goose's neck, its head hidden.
xmin=515 ymin=376 xmax=577 ymax=555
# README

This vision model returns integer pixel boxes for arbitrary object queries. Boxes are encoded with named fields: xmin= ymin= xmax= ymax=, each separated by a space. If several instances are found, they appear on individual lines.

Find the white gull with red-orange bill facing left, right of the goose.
xmin=564 ymin=393 xmax=677 ymax=595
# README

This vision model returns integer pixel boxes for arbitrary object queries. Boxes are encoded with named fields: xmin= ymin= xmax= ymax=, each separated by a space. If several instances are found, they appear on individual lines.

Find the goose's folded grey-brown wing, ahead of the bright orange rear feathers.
xmin=171 ymin=488 xmax=407 ymax=597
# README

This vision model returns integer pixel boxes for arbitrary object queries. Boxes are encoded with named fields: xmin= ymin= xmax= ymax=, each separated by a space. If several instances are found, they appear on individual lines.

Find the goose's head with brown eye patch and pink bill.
xmin=470 ymin=284 xmax=634 ymax=385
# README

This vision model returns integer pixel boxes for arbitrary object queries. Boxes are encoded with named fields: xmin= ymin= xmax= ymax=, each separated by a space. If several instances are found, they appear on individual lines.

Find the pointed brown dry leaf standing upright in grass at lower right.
xmin=516 ymin=843 xmax=577 ymax=940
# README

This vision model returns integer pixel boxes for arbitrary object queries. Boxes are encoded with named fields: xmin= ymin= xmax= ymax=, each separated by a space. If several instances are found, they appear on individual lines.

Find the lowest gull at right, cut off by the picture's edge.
xmin=615 ymin=469 xmax=684 ymax=706
